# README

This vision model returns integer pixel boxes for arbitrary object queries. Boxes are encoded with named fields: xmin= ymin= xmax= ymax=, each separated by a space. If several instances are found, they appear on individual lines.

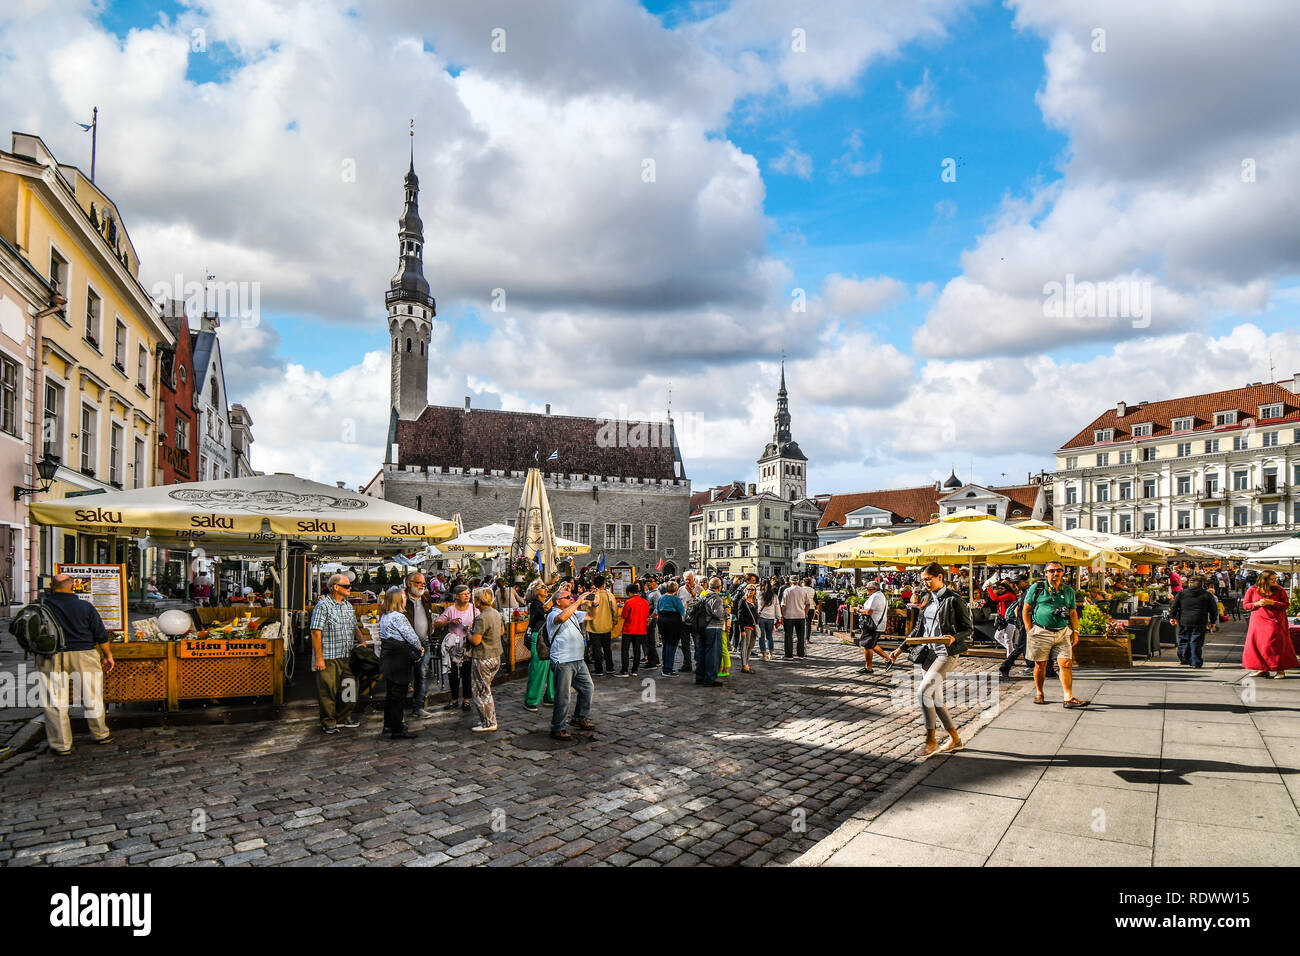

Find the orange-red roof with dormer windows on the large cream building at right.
xmin=1061 ymin=382 xmax=1300 ymax=449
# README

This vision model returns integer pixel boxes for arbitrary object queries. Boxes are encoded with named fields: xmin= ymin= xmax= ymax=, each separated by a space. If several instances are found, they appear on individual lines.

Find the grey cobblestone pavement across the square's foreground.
xmin=0 ymin=636 xmax=1027 ymax=866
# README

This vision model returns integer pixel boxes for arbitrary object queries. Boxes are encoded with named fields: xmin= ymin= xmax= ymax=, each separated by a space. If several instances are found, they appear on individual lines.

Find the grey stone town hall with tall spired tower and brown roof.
xmin=361 ymin=145 xmax=690 ymax=572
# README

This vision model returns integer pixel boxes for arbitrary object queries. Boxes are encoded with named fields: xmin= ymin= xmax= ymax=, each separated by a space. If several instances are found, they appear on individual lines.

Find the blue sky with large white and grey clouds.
xmin=0 ymin=0 xmax=1300 ymax=492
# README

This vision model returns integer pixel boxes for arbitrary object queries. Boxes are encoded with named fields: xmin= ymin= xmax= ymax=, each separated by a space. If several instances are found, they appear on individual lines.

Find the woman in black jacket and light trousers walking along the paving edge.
xmin=891 ymin=563 xmax=975 ymax=758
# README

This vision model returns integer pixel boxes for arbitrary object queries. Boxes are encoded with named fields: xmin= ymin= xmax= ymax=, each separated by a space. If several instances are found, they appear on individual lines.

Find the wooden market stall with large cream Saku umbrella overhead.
xmin=31 ymin=475 xmax=455 ymax=709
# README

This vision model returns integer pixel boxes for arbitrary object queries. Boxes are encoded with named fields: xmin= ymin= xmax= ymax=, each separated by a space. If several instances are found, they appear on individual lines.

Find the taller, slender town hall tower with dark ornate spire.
xmin=384 ymin=120 xmax=438 ymax=420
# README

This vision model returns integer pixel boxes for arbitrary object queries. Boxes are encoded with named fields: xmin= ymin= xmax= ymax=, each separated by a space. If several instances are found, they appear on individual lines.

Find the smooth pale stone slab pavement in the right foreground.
xmin=796 ymin=623 xmax=1300 ymax=866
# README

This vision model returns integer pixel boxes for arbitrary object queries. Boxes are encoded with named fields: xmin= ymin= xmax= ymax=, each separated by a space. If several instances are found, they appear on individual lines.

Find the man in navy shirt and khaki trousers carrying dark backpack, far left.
xmin=31 ymin=574 xmax=114 ymax=756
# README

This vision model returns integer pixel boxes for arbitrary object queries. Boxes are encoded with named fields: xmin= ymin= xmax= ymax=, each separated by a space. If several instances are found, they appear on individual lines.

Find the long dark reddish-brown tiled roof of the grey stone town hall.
xmin=397 ymin=405 xmax=685 ymax=479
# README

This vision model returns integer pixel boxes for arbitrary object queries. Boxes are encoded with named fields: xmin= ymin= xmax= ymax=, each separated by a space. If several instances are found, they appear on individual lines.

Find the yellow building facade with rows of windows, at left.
xmin=0 ymin=133 xmax=174 ymax=574
